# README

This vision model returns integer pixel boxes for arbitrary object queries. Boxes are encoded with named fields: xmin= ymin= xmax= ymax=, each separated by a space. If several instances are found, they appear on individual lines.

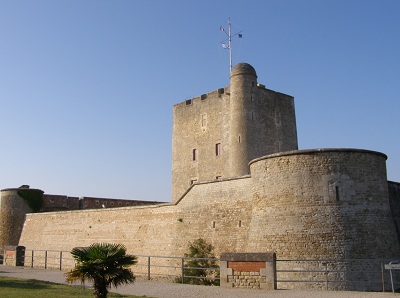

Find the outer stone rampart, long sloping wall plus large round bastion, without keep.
xmin=19 ymin=149 xmax=399 ymax=290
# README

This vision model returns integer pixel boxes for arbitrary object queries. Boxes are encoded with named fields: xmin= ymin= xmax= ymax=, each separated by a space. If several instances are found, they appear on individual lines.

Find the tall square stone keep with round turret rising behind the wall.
xmin=172 ymin=63 xmax=298 ymax=202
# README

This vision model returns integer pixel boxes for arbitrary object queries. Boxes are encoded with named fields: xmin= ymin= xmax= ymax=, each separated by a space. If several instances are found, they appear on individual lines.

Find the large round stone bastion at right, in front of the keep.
xmin=249 ymin=149 xmax=399 ymax=290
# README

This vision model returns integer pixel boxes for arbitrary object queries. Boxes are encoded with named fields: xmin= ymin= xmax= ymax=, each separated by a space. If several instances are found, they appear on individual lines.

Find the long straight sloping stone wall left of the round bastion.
xmin=20 ymin=177 xmax=251 ymax=256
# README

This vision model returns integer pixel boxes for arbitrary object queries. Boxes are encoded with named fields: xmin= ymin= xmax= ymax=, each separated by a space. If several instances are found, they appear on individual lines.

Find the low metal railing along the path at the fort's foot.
xmin=15 ymin=249 xmax=400 ymax=291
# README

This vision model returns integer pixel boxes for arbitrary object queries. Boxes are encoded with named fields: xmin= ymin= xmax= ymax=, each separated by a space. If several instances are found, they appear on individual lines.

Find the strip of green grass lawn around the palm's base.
xmin=0 ymin=277 xmax=145 ymax=298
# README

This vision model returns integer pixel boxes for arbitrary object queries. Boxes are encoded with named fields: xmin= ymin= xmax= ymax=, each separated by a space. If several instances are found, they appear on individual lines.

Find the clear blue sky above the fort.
xmin=0 ymin=0 xmax=400 ymax=201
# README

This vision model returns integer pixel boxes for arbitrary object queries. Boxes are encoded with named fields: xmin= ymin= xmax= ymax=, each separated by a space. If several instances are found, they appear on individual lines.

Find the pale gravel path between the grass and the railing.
xmin=0 ymin=265 xmax=400 ymax=298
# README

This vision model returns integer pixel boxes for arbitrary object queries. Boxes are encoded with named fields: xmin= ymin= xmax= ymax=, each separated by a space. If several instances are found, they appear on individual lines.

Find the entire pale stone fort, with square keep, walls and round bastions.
xmin=0 ymin=63 xmax=400 ymax=289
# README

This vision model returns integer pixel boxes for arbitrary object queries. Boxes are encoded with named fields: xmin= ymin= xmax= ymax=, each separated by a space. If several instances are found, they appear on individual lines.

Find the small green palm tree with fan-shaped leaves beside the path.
xmin=65 ymin=243 xmax=137 ymax=298
